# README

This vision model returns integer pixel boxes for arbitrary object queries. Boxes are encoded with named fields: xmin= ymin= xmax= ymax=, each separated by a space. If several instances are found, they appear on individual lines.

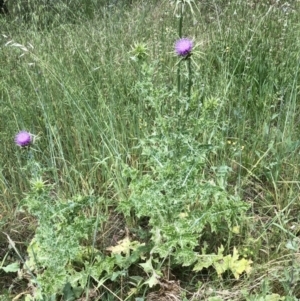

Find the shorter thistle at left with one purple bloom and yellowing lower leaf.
xmin=11 ymin=131 xmax=147 ymax=301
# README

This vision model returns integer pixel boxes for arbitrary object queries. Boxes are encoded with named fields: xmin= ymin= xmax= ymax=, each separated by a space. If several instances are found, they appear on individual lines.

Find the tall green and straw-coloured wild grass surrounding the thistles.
xmin=0 ymin=0 xmax=300 ymax=300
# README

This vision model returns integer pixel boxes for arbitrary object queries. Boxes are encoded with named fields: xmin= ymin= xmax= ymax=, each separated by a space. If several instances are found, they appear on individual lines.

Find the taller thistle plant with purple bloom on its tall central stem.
xmin=118 ymin=1 xmax=249 ymax=285
